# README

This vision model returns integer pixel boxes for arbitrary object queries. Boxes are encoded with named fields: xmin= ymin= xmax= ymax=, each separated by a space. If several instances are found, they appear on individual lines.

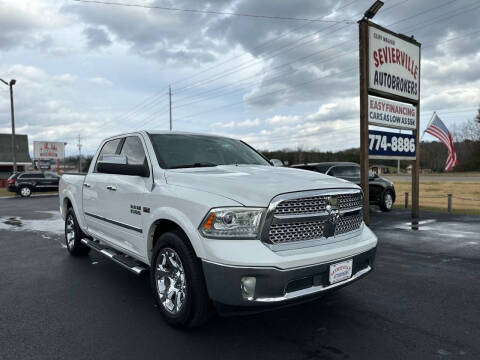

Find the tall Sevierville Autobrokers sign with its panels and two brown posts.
xmin=359 ymin=18 xmax=421 ymax=229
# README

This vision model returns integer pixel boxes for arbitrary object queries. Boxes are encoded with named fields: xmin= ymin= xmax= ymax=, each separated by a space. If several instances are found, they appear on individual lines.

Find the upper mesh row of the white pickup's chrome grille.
xmin=275 ymin=192 xmax=362 ymax=215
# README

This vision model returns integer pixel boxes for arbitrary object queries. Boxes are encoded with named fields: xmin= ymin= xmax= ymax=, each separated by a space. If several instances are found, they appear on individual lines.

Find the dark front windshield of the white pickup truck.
xmin=150 ymin=134 xmax=271 ymax=169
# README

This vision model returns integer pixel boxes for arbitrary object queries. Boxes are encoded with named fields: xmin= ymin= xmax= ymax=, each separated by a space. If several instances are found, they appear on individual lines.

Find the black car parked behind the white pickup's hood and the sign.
xmin=292 ymin=162 xmax=396 ymax=211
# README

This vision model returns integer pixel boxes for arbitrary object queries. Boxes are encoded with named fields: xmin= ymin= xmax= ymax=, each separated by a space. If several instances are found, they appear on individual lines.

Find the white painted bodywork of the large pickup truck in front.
xmin=59 ymin=132 xmax=377 ymax=269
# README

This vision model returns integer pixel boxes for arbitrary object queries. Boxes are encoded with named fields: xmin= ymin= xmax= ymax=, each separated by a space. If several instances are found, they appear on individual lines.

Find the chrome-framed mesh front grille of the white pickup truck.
xmin=262 ymin=190 xmax=363 ymax=245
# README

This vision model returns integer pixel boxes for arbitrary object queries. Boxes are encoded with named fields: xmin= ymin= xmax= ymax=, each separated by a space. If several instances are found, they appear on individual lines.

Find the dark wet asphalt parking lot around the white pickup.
xmin=0 ymin=196 xmax=480 ymax=360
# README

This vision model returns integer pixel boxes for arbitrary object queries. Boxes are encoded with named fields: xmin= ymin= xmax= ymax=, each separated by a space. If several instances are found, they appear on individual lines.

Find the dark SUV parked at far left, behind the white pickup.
xmin=7 ymin=171 xmax=60 ymax=197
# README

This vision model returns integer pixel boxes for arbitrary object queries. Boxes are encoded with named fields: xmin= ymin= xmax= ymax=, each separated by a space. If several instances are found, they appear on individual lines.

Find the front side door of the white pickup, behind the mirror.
xmin=108 ymin=135 xmax=152 ymax=256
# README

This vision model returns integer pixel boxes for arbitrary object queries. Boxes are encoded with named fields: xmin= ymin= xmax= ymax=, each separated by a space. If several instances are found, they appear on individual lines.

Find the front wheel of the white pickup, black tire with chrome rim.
xmin=150 ymin=231 xmax=213 ymax=328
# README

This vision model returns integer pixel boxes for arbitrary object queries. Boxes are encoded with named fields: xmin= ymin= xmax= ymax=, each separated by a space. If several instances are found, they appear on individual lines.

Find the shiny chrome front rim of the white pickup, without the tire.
xmin=155 ymin=248 xmax=187 ymax=315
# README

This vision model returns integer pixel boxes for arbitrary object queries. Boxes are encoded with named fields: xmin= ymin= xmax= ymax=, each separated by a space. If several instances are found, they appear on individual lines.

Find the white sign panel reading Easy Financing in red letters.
xmin=368 ymin=95 xmax=417 ymax=130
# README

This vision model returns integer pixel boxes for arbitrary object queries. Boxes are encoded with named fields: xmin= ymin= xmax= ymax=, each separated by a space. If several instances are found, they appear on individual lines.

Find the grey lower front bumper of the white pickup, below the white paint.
xmin=203 ymin=247 xmax=376 ymax=307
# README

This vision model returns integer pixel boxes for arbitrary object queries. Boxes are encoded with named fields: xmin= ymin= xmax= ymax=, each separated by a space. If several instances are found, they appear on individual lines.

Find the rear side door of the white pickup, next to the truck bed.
xmin=82 ymin=138 xmax=122 ymax=243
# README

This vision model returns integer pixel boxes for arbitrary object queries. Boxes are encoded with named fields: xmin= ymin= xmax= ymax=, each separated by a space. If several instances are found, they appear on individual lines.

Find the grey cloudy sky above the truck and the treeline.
xmin=0 ymin=0 xmax=480 ymax=154
